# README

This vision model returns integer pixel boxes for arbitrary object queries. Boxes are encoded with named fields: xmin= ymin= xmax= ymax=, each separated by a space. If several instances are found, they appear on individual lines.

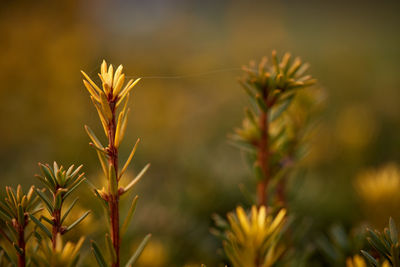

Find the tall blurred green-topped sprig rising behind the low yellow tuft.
xmin=231 ymin=51 xmax=316 ymax=205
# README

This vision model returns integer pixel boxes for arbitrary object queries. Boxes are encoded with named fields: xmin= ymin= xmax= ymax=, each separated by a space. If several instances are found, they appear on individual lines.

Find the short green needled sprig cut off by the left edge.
xmin=0 ymin=185 xmax=42 ymax=267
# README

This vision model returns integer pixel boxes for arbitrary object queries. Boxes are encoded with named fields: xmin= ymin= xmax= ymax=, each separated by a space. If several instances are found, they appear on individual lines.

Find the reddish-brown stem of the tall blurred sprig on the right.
xmin=256 ymin=92 xmax=269 ymax=206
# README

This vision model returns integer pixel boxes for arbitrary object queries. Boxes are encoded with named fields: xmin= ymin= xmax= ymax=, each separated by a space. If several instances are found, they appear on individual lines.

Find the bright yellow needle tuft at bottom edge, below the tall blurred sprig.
xmin=224 ymin=206 xmax=286 ymax=267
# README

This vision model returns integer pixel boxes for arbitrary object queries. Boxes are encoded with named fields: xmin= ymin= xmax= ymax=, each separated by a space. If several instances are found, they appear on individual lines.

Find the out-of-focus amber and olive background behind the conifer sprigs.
xmin=0 ymin=0 xmax=400 ymax=267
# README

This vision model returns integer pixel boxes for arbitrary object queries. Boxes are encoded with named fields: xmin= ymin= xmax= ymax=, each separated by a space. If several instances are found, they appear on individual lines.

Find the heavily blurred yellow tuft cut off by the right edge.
xmin=354 ymin=163 xmax=400 ymax=227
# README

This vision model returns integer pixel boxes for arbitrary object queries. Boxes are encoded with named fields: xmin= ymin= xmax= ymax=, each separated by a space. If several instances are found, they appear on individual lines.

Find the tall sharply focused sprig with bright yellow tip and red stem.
xmin=82 ymin=61 xmax=150 ymax=267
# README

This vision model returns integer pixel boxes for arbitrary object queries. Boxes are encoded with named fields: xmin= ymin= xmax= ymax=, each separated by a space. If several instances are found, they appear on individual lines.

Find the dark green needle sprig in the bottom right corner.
xmin=361 ymin=218 xmax=400 ymax=267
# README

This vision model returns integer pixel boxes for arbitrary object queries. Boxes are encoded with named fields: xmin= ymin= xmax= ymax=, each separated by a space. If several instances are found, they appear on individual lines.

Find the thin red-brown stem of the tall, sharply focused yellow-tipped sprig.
xmin=108 ymin=96 xmax=121 ymax=267
